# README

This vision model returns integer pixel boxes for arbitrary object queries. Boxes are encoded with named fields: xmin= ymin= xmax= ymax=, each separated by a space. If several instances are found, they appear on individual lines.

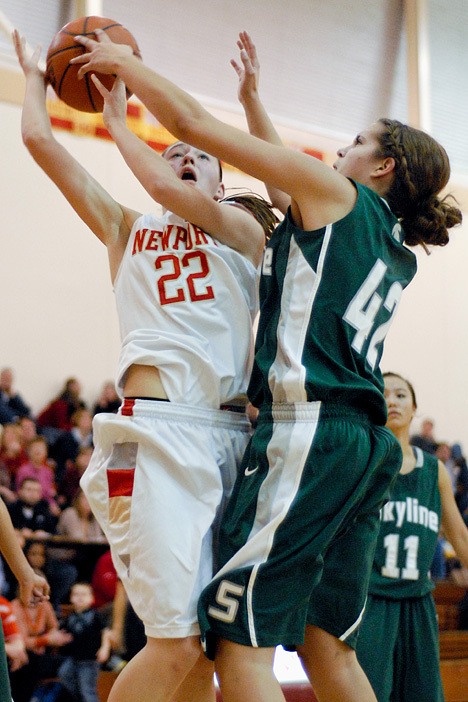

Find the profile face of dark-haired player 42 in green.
xmin=333 ymin=122 xmax=383 ymax=185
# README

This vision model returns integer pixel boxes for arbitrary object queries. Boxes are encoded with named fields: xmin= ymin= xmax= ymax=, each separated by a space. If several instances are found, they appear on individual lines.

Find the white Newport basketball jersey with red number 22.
xmin=114 ymin=212 xmax=258 ymax=408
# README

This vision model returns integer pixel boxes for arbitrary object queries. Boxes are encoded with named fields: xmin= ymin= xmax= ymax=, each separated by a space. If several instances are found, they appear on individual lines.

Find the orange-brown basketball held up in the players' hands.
xmin=46 ymin=17 xmax=141 ymax=112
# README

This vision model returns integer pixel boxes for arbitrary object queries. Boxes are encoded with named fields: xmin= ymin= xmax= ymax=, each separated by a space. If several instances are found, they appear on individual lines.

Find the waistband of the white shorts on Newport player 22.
xmin=119 ymin=397 xmax=250 ymax=430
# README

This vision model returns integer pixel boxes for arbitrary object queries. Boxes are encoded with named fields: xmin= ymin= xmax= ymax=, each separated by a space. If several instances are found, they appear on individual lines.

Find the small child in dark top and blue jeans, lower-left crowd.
xmin=59 ymin=583 xmax=111 ymax=702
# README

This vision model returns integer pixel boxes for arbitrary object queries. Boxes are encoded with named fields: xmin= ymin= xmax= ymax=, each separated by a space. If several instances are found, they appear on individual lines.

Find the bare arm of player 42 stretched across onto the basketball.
xmin=72 ymin=30 xmax=356 ymax=229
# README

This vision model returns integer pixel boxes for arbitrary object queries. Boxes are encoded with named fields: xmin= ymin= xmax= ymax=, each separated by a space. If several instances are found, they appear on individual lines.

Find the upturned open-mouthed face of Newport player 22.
xmin=163 ymin=142 xmax=224 ymax=200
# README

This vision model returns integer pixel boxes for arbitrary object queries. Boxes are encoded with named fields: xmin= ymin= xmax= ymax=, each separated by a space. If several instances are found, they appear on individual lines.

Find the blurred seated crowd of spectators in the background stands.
xmin=0 ymin=368 xmax=468 ymax=702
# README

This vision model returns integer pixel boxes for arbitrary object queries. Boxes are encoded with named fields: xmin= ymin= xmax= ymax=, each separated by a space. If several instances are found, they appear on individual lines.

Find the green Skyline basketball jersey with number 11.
xmin=369 ymin=446 xmax=441 ymax=599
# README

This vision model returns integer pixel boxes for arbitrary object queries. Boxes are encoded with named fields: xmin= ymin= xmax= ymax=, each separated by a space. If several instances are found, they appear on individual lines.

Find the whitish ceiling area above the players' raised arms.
xmin=0 ymin=0 xmax=468 ymax=176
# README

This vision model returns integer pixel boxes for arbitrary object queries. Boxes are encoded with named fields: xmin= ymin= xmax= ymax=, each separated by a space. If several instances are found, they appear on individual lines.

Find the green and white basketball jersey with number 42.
xmin=249 ymin=184 xmax=416 ymax=424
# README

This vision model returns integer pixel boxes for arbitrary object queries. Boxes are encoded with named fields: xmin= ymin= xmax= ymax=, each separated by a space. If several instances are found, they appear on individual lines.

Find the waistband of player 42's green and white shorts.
xmin=258 ymin=402 xmax=373 ymax=424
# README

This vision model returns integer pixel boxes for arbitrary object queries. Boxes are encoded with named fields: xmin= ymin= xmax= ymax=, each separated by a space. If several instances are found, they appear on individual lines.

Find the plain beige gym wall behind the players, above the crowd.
xmin=0 ymin=74 xmax=468 ymax=451
